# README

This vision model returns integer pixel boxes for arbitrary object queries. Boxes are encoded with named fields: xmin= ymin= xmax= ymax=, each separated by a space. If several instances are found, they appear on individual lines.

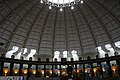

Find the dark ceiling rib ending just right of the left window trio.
xmin=37 ymin=10 xmax=51 ymax=54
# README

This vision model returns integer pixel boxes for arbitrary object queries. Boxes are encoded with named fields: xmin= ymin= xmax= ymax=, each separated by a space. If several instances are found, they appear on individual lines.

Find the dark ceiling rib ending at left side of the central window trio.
xmin=52 ymin=8 xmax=58 ymax=58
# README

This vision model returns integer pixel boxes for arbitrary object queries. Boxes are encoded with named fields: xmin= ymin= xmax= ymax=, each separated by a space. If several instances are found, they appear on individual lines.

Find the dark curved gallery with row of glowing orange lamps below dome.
xmin=0 ymin=54 xmax=120 ymax=79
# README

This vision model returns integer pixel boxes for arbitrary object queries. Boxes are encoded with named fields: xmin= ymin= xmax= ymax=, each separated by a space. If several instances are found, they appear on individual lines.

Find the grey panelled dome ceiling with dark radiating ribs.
xmin=0 ymin=0 xmax=120 ymax=56
